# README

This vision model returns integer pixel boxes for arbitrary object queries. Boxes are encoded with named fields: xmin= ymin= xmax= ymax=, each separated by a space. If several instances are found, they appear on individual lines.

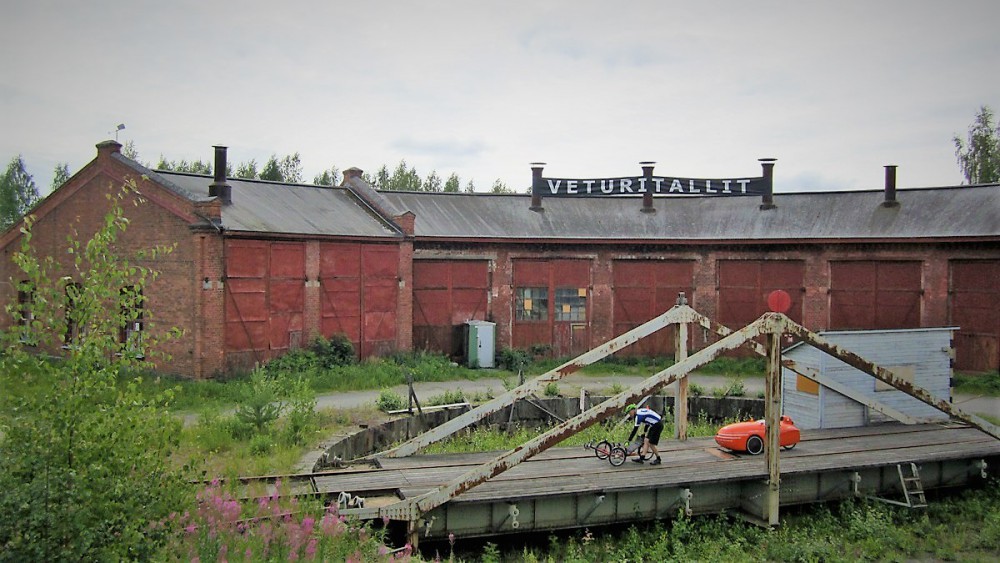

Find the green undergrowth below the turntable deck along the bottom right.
xmin=455 ymin=482 xmax=1000 ymax=563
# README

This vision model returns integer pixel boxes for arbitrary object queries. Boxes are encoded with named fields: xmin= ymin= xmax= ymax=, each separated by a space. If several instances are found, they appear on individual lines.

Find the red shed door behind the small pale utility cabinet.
xmin=413 ymin=260 xmax=490 ymax=357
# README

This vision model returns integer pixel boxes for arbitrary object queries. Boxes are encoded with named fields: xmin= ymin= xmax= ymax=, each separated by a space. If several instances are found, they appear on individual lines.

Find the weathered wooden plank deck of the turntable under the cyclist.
xmin=316 ymin=424 xmax=1000 ymax=503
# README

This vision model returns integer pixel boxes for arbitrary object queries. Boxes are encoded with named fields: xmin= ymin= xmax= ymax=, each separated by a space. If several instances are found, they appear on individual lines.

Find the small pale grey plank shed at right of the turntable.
xmin=782 ymin=327 xmax=957 ymax=429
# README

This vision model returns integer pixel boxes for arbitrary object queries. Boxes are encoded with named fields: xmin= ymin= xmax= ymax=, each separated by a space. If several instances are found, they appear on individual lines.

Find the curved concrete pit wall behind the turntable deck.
xmin=313 ymin=395 xmax=764 ymax=472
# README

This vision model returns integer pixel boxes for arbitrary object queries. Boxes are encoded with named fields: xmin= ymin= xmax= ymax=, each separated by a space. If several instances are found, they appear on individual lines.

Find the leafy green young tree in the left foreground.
xmin=0 ymin=185 xmax=191 ymax=561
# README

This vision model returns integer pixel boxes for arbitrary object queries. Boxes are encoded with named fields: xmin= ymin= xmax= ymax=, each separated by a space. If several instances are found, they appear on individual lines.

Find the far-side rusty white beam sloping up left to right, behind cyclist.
xmin=374 ymin=305 xmax=695 ymax=457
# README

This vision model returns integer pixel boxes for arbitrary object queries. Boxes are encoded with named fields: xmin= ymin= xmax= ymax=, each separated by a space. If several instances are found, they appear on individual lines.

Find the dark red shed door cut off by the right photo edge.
xmin=949 ymin=260 xmax=1000 ymax=371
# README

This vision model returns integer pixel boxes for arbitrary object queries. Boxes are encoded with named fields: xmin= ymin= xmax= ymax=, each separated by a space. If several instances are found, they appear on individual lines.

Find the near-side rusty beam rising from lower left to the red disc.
xmin=379 ymin=314 xmax=781 ymax=522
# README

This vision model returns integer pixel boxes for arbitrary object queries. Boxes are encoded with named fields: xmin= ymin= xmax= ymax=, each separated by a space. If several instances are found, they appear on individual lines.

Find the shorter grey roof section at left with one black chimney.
xmin=157 ymin=171 xmax=401 ymax=238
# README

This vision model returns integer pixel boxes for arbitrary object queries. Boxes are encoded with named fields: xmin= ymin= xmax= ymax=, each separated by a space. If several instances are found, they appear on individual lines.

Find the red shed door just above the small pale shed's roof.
xmin=830 ymin=260 xmax=922 ymax=330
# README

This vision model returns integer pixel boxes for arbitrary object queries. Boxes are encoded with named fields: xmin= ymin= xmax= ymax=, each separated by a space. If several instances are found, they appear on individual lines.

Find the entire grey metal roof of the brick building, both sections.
xmin=148 ymin=164 xmax=1000 ymax=242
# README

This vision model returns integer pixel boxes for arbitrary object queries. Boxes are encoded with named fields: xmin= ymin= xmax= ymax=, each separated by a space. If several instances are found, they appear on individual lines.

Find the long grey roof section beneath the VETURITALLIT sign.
xmin=383 ymin=184 xmax=1000 ymax=241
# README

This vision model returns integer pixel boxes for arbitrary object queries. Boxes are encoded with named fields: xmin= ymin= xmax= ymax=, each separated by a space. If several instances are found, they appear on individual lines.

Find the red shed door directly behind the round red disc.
xmin=718 ymin=260 xmax=805 ymax=330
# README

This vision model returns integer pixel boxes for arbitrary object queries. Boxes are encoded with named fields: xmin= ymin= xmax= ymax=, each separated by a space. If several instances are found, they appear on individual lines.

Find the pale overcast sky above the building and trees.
xmin=0 ymin=0 xmax=1000 ymax=194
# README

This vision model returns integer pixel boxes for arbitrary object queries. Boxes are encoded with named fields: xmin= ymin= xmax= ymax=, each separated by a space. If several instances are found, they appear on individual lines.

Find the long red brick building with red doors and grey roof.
xmin=0 ymin=141 xmax=1000 ymax=377
